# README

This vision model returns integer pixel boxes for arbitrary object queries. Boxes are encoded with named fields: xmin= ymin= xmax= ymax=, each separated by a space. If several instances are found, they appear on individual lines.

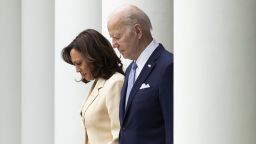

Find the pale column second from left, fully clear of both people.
xmin=21 ymin=0 xmax=54 ymax=144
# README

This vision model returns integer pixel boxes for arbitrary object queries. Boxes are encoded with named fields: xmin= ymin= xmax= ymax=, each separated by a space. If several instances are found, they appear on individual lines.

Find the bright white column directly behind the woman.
xmin=54 ymin=0 xmax=101 ymax=144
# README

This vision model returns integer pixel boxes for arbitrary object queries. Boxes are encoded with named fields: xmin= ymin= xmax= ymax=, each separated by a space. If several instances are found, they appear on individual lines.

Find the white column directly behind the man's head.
xmin=102 ymin=0 xmax=173 ymax=68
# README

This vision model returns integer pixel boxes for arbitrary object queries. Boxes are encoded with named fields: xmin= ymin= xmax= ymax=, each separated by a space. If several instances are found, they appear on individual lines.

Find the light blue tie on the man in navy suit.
xmin=125 ymin=62 xmax=138 ymax=108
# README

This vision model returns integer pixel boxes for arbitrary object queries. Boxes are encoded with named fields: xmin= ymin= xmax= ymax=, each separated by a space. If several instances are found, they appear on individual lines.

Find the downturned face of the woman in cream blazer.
xmin=70 ymin=48 xmax=94 ymax=81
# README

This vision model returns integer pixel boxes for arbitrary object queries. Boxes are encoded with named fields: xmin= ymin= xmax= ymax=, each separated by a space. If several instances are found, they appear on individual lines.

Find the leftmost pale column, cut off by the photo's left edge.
xmin=0 ymin=0 xmax=21 ymax=144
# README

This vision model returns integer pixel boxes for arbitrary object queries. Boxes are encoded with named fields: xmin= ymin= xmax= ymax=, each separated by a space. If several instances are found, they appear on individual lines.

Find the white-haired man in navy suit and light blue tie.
xmin=108 ymin=5 xmax=173 ymax=144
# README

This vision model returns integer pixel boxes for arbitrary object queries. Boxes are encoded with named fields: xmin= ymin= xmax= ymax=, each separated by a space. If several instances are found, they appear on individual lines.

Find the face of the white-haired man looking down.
xmin=108 ymin=19 xmax=138 ymax=60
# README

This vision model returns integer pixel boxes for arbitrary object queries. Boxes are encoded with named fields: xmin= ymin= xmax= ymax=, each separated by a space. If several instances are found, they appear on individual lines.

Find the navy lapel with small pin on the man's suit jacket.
xmin=122 ymin=44 xmax=163 ymax=124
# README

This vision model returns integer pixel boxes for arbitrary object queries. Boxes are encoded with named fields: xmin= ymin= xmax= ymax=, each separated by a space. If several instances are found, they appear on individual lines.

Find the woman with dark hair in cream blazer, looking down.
xmin=62 ymin=29 xmax=124 ymax=144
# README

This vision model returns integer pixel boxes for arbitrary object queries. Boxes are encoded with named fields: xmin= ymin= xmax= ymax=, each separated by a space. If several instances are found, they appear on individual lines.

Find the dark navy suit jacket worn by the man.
xmin=119 ymin=44 xmax=173 ymax=144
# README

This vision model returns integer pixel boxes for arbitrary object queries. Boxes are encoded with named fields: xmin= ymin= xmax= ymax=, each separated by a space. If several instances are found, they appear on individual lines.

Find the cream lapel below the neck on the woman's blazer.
xmin=82 ymin=78 xmax=105 ymax=113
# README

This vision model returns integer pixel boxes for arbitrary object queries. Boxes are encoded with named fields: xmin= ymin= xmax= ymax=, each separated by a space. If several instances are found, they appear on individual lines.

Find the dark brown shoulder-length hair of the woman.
xmin=61 ymin=29 xmax=124 ymax=83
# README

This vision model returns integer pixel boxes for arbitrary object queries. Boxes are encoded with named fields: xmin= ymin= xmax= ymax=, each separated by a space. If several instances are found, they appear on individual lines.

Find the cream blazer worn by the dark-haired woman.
xmin=80 ymin=73 xmax=124 ymax=144
